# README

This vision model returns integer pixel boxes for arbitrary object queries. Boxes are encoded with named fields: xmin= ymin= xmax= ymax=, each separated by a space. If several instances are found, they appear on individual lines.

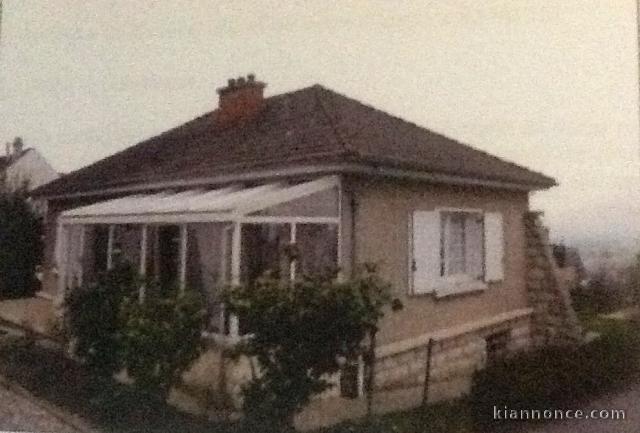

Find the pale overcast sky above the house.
xmin=0 ymin=0 xmax=640 ymax=246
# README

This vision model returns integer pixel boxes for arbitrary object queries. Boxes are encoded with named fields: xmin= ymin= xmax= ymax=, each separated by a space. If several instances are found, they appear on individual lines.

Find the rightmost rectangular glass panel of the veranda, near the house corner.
xmin=296 ymin=224 xmax=338 ymax=276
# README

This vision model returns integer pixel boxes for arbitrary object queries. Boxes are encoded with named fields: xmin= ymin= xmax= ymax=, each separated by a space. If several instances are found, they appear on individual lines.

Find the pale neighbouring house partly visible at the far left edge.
xmin=0 ymin=137 xmax=58 ymax=191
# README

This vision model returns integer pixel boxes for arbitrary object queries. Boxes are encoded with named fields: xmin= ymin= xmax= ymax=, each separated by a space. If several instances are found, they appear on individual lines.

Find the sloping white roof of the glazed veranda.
xmin=59 ymin=176 xmax=339 ymax=225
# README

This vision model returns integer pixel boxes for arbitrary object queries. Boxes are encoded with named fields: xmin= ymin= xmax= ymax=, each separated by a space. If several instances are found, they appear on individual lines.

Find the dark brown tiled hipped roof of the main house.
xmin=35 ymin=85 xmax=555 ymax=196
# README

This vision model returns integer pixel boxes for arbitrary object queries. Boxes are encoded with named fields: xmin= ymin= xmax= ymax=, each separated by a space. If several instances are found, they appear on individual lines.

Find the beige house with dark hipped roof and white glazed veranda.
xmin=35 ymin=75 xmax=579 ymax=424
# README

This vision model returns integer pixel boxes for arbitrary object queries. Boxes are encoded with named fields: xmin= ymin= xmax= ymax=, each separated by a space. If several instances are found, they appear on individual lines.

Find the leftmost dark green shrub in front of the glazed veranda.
xmin=65 ymin=262 xmax=138 ymax=376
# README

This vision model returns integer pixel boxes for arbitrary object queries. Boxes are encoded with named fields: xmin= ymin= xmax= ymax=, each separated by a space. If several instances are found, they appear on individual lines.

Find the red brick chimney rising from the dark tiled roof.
xmin=215 ymin=74 xmax=266 ymax=125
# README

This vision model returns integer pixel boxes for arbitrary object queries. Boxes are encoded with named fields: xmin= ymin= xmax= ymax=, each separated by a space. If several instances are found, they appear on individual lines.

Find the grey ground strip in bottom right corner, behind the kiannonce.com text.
xmin=523 ymin=384 xmax=640 ymax=433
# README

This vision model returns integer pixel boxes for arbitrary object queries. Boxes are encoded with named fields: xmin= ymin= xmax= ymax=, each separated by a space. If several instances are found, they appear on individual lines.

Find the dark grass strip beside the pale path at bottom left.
xmin=0 ymin=336 xmax=233 ymax=433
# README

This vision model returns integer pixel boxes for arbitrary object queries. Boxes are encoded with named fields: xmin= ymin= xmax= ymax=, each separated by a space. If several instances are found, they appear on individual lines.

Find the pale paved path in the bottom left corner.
xmin=0 ymin=381 xmax=89 ymax=433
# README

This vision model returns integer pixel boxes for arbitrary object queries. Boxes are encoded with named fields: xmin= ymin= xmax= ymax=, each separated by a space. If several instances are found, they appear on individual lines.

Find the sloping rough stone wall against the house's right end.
xmin=524 ymin=212 xmax=583 ymax=346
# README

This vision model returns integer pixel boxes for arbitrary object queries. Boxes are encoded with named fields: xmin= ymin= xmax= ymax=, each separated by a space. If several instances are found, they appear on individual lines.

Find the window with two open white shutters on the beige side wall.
xmin=411 ymin=209 xmax=504 ymax=296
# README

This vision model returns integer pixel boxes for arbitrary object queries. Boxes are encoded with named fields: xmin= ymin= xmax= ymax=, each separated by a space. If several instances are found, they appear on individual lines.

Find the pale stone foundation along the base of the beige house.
xmin=171 ymin=309 xmax=532 ymax=429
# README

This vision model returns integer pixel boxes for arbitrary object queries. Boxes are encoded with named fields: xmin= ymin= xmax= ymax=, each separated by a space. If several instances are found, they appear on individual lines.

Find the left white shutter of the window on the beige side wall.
xmin=412 ymin=211 xmax=440 ymax=293
